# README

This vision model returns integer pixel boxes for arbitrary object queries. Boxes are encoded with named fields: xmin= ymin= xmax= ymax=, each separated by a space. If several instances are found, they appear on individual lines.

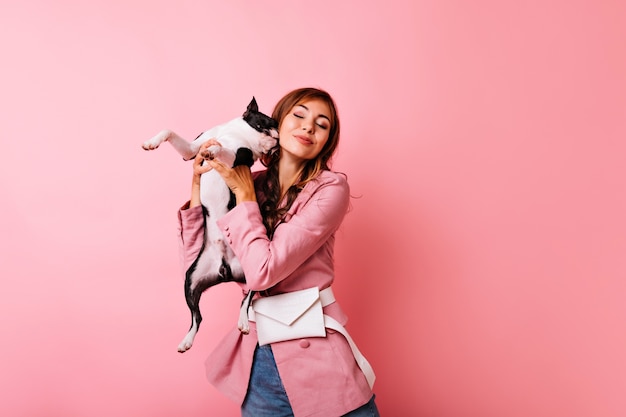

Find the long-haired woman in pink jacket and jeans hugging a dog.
xmin=179 ymin=88 xmax=379 ymax=417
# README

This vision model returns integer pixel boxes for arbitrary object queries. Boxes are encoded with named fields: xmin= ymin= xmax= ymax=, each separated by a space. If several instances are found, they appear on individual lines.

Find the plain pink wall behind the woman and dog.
xmin=0 ymin=0 xmax=626 ymax=417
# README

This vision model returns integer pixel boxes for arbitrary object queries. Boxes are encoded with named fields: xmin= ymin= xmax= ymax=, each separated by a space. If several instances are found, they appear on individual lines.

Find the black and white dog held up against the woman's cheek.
xmin=142 ymin=97 xmax=278 ymax=352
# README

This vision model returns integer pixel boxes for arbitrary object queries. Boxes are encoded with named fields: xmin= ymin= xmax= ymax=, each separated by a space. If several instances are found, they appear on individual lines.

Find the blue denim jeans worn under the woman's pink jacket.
xmin=241 ymin=345 xmax=380 ymax=417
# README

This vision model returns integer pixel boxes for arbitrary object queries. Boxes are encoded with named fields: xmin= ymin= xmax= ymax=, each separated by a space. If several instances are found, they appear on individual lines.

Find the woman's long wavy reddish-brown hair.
xmin=260 ymin=87 xmax=340 ymax=238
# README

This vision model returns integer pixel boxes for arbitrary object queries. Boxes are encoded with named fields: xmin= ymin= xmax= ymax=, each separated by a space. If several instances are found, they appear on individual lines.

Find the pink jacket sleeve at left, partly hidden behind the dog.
xmin=178 ymin=202 xmax=204 ymax=275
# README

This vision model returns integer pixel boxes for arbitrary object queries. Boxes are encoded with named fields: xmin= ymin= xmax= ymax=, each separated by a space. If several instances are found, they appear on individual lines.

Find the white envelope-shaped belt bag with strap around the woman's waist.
xmin=240 ymin=287 xmax=376 ymax=387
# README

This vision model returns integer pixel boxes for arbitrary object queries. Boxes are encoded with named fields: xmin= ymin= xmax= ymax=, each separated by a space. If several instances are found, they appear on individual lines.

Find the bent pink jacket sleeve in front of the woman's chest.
xmin=218 ymin=174 xmax=350 ymax=291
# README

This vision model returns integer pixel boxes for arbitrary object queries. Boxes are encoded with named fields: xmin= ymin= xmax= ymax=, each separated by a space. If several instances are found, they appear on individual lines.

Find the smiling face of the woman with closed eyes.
xmin=278 ymin=99 xmax=331 ymax=161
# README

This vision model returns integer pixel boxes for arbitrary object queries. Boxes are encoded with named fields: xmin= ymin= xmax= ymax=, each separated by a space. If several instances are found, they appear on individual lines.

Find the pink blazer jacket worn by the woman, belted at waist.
xmin=179 ymin=171 xmax=372 ymax=417
